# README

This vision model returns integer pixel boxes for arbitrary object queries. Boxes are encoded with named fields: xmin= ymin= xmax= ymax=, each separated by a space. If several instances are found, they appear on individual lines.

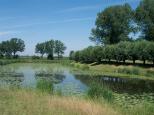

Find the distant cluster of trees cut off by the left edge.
xmin=0 ymin=38 xmax=25 ymax=58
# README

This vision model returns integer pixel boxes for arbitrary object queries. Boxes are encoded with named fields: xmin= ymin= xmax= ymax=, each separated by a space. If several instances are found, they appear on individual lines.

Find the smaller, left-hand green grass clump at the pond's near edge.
xmin=36 ymin=80 xmax=54 ymax=94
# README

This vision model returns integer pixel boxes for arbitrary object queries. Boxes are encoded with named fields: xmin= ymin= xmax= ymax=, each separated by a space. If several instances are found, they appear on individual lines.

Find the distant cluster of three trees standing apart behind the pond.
xmin=35 ymin=40 xmax=66 ymax=60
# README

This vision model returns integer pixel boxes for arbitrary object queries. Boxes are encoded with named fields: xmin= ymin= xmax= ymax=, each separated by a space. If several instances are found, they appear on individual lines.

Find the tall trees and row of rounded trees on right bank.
xmin=70 ymin=0 xmax=154 ymax=64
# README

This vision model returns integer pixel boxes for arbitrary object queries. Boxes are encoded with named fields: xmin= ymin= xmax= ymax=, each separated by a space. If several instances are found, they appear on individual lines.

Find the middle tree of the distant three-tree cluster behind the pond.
xmin=45 ymin=40 xmax=55 ymax=60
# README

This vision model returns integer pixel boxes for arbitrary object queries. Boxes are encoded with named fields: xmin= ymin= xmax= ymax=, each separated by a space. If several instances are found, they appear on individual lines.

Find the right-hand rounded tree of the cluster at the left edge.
xmin=10 ymin=38 xmax=25 ymax=57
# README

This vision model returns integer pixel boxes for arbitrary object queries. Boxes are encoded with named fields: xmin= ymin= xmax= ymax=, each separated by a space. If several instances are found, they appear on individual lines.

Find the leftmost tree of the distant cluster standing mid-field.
xmin=35 ymin=43 xmax=46 ymax=58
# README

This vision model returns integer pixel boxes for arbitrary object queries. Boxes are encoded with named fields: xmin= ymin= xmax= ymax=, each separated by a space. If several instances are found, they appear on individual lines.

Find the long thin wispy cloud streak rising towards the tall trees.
xmin=1 ymin=17 xmax=95 ymax=29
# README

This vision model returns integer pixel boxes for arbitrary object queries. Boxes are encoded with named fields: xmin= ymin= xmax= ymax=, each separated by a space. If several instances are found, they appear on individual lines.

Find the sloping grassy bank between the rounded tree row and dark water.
xmin=71 ymin=62 xmax=154 ymax=80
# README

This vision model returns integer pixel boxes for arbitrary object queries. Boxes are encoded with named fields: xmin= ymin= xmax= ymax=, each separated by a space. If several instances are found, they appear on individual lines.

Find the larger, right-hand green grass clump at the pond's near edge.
xmin=88 ymin=83 xmax=114 ymax=102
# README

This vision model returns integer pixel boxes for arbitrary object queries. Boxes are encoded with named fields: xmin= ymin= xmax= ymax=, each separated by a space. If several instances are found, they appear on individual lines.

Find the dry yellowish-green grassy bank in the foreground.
xmin=0 ymin=89 xmax=120 ymax=115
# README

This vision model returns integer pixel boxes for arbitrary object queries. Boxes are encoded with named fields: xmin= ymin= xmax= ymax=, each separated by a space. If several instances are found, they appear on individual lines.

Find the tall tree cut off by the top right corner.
xmin=135 ymin=0 xmax=154 ymax=41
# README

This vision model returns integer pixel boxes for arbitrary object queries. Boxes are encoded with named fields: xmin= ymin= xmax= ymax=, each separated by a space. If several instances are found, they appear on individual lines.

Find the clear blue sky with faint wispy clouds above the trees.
xmin=0 ymin=0 xmax=140 ymax=55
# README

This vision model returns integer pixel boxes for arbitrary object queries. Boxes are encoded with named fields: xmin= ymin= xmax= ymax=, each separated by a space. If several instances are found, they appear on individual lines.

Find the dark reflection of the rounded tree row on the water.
xmin=75 ymin=75 xmax=154 ymax=94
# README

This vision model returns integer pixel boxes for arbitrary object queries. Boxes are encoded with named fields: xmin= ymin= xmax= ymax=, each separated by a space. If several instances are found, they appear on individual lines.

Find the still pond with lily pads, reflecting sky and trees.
xmin=0 ymin=63 xmax=154 ymax=107
